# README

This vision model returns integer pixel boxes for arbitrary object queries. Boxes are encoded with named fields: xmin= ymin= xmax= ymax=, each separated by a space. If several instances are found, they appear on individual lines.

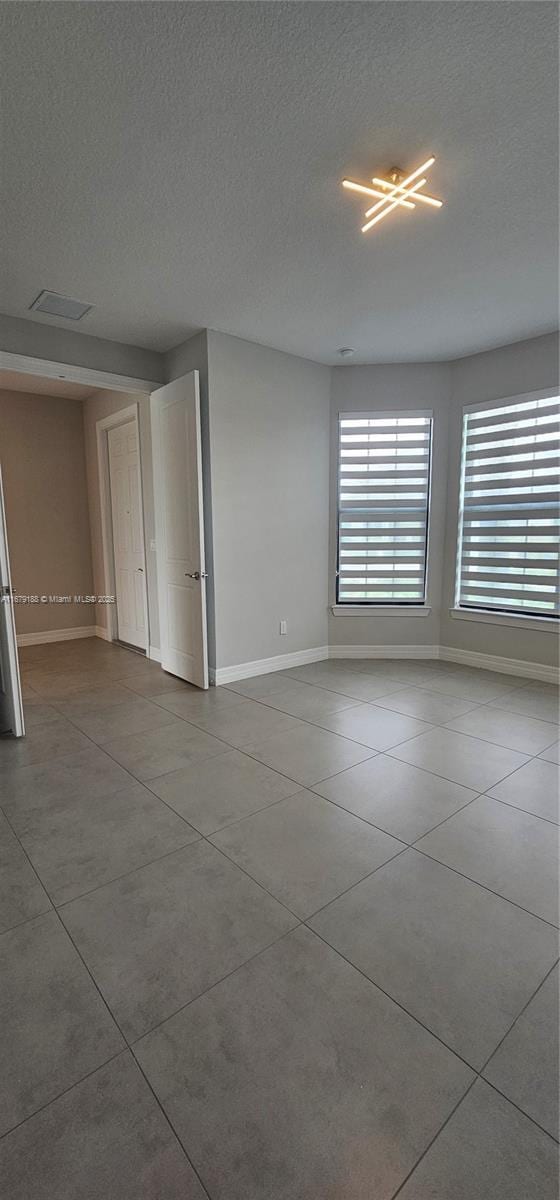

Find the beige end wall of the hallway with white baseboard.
xmin=0 ymin=391 xmax=95 ymax=634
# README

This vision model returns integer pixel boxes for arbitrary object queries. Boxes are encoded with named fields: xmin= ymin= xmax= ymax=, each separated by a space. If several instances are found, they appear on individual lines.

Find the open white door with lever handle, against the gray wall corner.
xmin=151 ymin=371 xmax=209 ymax=688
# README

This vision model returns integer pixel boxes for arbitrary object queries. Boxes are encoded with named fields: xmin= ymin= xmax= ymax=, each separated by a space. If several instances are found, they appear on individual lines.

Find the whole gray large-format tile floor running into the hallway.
xmin=0 ymin=638 xmax=559 ymax=1200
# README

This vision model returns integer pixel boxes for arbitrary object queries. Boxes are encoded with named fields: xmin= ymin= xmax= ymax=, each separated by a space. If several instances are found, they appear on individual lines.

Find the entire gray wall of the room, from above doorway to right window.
xmin=0 ymin=316 xmax=558 ymax=667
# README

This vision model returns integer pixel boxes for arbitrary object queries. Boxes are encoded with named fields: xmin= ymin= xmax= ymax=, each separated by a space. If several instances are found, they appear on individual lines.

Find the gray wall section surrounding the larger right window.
xmin=440 ymin=334 xmax=559 ymax=665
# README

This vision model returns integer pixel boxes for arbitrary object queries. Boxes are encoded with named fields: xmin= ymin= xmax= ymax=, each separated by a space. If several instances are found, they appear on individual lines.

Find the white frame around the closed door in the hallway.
xmin=96 ymin=401 xmax=150 ymax=659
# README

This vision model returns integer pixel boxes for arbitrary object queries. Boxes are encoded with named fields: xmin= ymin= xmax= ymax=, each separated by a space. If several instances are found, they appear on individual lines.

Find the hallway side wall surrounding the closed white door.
xmin=84 ymin=391 xmax=159 ymax=648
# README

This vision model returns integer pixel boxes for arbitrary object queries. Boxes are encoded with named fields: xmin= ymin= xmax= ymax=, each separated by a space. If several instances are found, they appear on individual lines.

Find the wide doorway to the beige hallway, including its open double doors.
xmin=0 ymin=355 xmax=209 ymax=736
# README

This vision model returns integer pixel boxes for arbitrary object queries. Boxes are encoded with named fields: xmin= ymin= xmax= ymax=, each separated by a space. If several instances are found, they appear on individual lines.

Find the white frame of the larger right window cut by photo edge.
xmin=450 ymin=388 xmax=560 ymax=634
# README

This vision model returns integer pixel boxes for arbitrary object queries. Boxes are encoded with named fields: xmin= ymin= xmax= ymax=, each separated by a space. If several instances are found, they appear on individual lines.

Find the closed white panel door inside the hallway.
xmin=107 ymin=421 xmax=147 ymax=650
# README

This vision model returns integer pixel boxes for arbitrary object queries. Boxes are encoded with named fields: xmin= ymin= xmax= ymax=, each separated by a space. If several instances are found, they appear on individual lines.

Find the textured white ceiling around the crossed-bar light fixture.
xmin=0 ymin=0 xmax=558 ymax=362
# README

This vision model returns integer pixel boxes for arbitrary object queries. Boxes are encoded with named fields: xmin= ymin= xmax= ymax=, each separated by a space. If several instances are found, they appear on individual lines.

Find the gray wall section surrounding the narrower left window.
xmin=329 ymin=362 xmax=451 ymax=646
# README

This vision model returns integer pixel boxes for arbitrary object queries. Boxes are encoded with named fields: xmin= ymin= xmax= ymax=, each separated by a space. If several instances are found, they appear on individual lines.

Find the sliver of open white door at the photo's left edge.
xmin=0 ymin=468 xmax=25 ymax=738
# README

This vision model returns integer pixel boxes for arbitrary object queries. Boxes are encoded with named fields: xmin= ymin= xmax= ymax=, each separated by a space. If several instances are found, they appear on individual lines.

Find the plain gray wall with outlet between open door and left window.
xmin=209 ymin=331 xmax=330 ymax=667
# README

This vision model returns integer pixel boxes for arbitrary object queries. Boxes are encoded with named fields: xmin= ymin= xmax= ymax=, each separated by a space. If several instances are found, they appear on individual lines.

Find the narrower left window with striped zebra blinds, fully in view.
xmin=337 ymin=413 xmax=432 ymax=605
